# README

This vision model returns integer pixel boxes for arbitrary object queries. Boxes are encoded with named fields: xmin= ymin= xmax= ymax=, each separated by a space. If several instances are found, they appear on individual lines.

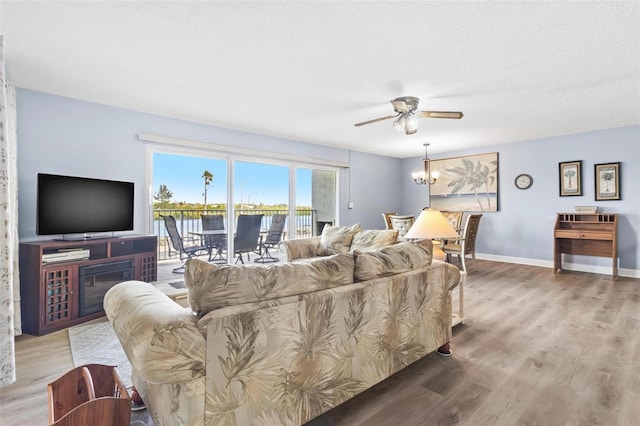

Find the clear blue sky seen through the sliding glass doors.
xmin=153 ymin=153 xmax=311 ymax=206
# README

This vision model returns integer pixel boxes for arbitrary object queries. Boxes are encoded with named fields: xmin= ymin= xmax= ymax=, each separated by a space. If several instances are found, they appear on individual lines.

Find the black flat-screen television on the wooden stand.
xmin=36 ymin=173 xmax=134 ymax=236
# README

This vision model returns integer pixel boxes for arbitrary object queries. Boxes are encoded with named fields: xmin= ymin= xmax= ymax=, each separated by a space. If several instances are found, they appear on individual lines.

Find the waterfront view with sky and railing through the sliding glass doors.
xmin=152 ymin=153 xmax=336 ymax=259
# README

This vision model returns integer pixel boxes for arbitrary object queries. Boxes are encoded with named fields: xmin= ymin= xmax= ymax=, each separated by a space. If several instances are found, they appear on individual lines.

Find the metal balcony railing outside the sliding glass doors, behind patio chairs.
xmin=152 ymin=209 xmax=316 ymax=260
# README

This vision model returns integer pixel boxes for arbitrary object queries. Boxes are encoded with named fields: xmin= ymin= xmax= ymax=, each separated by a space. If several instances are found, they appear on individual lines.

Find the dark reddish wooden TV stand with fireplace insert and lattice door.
xmin=20 ymin=235 xmax=158 ymax=336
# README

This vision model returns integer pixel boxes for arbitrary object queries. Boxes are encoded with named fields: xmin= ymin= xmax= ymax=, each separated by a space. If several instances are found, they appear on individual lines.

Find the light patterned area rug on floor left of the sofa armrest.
xmin=69 ymin=318 xmax=131 ymax=388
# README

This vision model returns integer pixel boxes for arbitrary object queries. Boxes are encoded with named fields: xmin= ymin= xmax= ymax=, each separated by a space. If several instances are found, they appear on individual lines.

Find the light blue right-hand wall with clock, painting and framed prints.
xmin=403 ymin=126 xmax=640 ymax=271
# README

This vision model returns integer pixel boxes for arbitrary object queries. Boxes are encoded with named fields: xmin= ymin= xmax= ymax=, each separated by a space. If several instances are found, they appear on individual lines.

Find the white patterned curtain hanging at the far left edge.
xmin=0 ymin=36 xmax=22 ymax=386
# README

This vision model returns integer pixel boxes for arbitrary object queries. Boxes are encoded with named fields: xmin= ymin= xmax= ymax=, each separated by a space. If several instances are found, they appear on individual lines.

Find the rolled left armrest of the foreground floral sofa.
xmin=104 ymin=281 xmax=206 ymax=384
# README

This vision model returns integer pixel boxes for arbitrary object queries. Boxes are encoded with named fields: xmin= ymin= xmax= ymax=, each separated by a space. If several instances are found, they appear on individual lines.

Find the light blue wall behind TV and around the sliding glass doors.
xmin=16 ymin=89 xmax=402 ymax=240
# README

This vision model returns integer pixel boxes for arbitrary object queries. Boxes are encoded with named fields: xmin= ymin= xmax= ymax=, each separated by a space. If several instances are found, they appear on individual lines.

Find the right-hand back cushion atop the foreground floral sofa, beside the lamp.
xmin=353 ymin=240 xmax=433 ymax=282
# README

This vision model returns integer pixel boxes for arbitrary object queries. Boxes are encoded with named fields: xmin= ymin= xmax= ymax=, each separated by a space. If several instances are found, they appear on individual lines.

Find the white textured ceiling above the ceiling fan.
xmin=0 ymin=1 xmax=640 ymax=158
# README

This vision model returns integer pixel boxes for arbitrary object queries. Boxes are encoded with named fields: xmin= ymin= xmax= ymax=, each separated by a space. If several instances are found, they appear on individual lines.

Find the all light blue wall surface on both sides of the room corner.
xmin=17 ymin=89 xmax=640 ymax=271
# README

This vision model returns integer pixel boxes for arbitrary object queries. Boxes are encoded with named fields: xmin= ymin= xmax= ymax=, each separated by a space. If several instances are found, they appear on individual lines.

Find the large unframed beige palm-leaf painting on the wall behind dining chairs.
xmin=427 ymin=152 xmax=499 ymax=212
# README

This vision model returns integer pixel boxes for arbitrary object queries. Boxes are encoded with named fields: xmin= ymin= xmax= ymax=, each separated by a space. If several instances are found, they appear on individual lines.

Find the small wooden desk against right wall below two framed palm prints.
xmin=553 ymin=213 xmax=618 ymax=279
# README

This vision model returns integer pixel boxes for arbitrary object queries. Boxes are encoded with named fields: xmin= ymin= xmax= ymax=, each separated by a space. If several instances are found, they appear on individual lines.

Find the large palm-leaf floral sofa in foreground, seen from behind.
xmin=104 ymin=241 xmax=460 ymax=426
